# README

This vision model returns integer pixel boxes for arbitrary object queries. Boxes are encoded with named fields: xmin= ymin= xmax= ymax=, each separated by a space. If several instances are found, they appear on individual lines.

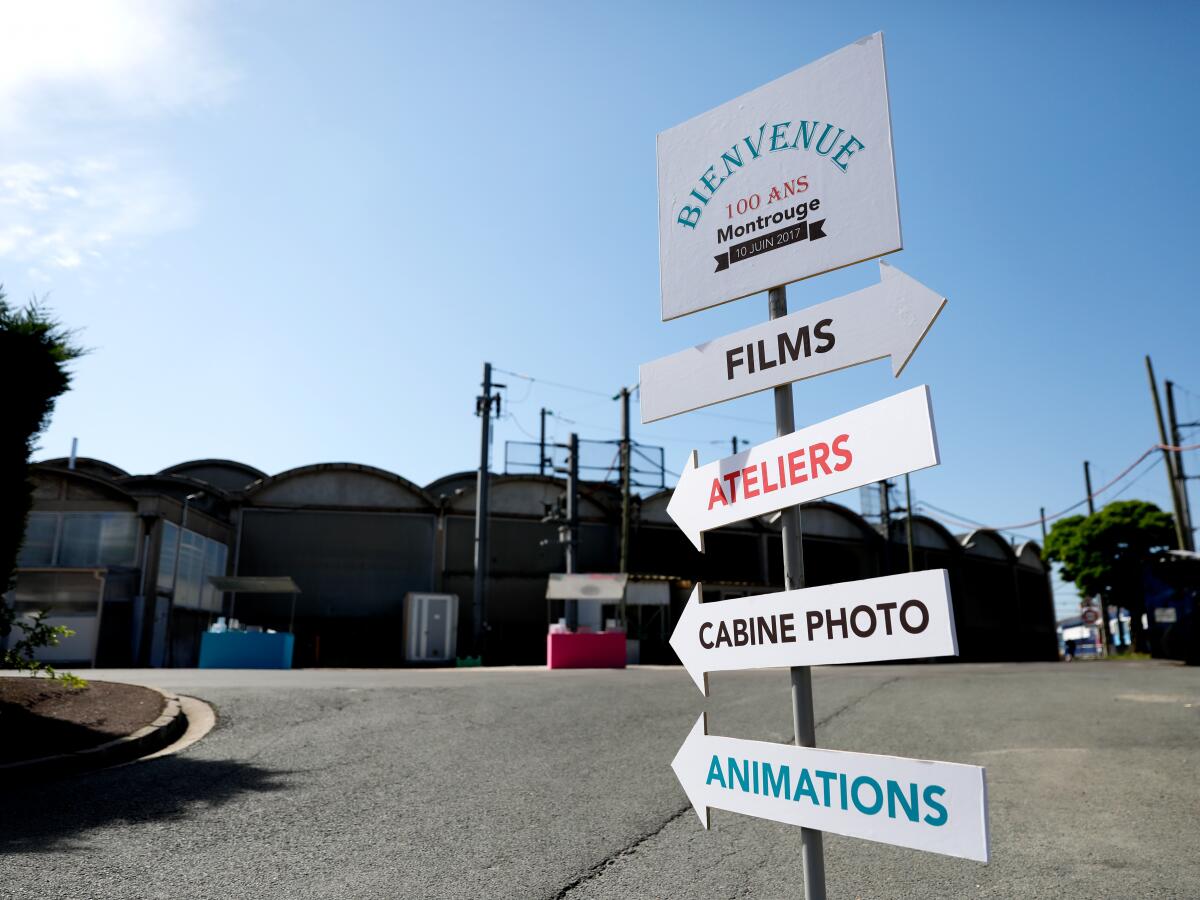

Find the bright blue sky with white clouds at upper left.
xmin=0 ymin=2 xmax=1200 ymax=619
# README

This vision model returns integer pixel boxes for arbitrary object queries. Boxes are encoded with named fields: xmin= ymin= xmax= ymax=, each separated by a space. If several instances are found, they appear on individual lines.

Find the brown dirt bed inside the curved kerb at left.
xmin=0 ymin=676 xmax=164 ymax=763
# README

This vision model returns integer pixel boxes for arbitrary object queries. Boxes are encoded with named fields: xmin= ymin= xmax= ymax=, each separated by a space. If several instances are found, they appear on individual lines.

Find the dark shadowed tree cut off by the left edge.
xmin=0 ymin=287 xmax=85 ymax=664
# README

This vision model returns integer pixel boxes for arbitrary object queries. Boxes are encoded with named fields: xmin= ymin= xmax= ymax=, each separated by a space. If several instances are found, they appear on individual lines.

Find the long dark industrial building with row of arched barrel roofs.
xmin=10 ymin=458 xmax=1057 ymax=666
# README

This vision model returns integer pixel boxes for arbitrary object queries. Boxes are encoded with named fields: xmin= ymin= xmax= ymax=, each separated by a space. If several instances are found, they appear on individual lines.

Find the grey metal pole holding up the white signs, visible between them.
xmin=768 ymin=287 xmax=826 ymax=900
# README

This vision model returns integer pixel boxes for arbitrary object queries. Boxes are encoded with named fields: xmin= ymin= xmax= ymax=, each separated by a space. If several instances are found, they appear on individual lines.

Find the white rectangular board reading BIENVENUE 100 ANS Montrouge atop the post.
xmin=659 ymin=34 xmax=901 ymax=320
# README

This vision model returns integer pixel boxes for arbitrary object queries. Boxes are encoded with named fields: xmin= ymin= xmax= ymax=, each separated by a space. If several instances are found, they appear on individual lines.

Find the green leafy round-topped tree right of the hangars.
xmin=1045 ymin=500 xmax=1175 ymax=652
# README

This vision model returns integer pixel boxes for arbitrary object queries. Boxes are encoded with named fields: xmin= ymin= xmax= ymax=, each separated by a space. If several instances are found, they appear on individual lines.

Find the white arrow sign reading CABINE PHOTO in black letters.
xmin=671 ymin=569 xmax=959 ymax=696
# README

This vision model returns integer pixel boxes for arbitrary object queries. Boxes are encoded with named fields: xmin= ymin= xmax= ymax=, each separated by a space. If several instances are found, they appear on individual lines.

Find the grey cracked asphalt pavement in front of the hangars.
xmin=0 ymin=662 xmax=1200 ymax=900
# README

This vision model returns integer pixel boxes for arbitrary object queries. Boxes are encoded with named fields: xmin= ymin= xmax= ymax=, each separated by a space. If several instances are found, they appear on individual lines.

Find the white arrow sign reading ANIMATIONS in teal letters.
xmin=671 ymin=715 xmax=988 ymax=863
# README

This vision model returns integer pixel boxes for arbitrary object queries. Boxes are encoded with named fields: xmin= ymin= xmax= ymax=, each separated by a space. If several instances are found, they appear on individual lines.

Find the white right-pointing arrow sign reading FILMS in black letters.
xmin=640 ymin=262 xmax=946 ymax=424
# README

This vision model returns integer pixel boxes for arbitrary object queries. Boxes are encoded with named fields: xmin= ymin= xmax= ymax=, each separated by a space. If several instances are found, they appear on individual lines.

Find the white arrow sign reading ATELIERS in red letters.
xmin=667 ymin=385 xmax=938 ymax=553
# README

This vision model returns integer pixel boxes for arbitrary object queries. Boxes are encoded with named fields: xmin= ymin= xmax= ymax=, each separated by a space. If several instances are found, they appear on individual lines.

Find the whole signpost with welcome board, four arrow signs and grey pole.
xmin=641 ymin=34 xmax=988 ymax=900
